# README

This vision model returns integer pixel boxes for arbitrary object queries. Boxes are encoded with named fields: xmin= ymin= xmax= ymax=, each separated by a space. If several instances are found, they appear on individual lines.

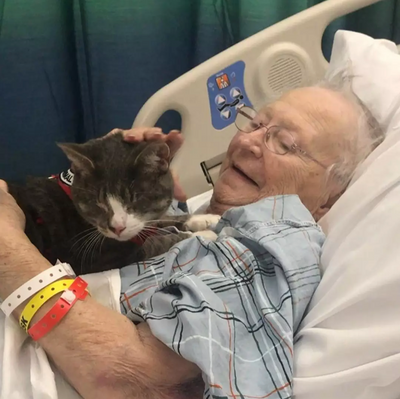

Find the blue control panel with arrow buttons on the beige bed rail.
xmin=207 ymin=61 xmax=251 ymax=130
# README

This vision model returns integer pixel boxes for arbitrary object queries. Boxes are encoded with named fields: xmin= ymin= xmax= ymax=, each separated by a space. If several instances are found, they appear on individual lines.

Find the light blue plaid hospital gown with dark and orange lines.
xmin=121 ymin=195 xmax=324 ymax=399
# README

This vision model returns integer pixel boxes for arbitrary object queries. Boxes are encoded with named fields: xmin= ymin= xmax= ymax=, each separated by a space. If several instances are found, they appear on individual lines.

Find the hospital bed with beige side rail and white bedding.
xmin=0 ymin=0 xmax=400 ymax=399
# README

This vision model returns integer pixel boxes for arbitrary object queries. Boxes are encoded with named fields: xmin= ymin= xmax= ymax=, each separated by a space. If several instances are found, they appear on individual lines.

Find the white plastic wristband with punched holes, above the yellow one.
xmin=0 ymin=263 xmax=75 ymax=317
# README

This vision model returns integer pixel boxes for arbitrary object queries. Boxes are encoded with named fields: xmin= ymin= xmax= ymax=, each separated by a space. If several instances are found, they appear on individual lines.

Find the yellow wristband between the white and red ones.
xmin=19 ymin=279 xmax=74 ymax=332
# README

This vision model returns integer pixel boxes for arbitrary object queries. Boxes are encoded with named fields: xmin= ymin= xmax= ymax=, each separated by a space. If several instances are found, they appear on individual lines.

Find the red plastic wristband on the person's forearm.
xmin=28 ymin=277 xmax=88 ymax=341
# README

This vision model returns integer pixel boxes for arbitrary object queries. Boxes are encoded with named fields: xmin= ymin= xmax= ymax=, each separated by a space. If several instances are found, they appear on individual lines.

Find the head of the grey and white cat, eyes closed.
xmin=58 ymin=134 xmax=173 ymax=241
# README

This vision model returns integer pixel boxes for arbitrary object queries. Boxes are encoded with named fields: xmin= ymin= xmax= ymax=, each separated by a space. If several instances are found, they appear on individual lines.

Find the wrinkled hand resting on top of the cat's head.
xmin=108 ymin=127 xmax=187 ymax=201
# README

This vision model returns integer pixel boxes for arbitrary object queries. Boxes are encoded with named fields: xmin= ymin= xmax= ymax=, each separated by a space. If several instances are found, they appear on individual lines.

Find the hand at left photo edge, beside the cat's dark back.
xmin=0 ymin=180 xmax=25 ymax=234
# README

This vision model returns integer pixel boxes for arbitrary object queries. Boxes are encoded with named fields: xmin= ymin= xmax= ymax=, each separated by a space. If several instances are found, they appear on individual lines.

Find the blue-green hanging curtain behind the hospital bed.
xmin=0 ymin=0 xmax=400 ymax=180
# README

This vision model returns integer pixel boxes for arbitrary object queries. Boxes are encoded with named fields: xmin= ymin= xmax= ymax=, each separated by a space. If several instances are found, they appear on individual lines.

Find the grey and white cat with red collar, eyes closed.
xmin=9 ymin=133 xmax=219 ymax=274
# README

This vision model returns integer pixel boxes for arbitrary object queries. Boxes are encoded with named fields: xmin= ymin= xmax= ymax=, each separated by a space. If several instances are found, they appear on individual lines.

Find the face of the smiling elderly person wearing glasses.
xmin=211 ymin=88 xmax=358 ymax=219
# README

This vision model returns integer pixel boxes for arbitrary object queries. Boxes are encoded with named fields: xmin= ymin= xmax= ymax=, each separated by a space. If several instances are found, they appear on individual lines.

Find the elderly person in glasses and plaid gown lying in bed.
xmin=0 ymin=83 xmax=380 ymax=399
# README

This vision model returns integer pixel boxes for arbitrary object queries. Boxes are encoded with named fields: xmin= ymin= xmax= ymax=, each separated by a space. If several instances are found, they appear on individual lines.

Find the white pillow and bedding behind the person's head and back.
xmin=294 ymin=31 xmax=400 ymax=399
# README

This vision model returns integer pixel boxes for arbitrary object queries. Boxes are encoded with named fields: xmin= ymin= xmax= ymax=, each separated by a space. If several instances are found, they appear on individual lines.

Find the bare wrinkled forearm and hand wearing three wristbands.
xmin=0 ymin=184 xmax=201 ymax=399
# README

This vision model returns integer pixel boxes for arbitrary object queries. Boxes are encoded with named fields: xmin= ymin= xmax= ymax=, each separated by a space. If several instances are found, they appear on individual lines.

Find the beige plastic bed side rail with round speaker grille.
xmin=133 ymin=0 xmax=388 ymax=197
